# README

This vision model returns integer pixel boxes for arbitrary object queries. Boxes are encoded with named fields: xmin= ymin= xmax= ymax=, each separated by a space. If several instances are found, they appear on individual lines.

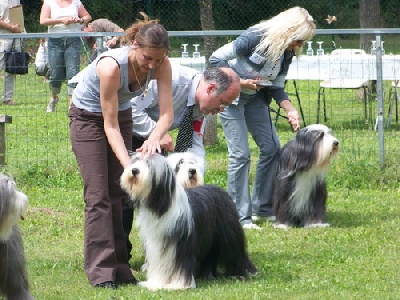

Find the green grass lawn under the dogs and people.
xmin=1 ymin=64 xmax=400 ymax=300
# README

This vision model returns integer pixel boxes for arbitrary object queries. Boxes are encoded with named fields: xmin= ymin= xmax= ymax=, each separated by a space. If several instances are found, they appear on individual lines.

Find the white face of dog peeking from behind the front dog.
xmin=167 ymin=151 xmax=204 ymax=189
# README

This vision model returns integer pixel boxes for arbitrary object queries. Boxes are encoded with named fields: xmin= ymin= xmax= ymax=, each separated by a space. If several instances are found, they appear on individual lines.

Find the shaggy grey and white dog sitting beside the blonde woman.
xmin=273 ymin=124 xmax=339 ymax=228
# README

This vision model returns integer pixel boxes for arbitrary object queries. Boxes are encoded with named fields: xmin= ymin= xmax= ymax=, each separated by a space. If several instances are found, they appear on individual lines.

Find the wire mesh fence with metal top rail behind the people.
xmin=0 ymin=29 xmax=400 ymax=175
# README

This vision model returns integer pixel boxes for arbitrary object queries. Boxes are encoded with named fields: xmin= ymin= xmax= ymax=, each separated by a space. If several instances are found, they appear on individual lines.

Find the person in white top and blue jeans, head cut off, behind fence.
xmin=40 ymin=0 xmax=92 ymax=112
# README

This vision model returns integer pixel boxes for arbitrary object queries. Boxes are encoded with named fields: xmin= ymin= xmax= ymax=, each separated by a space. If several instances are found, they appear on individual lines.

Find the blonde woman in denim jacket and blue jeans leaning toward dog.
xmin=209 ymin=7 xmax=315 ymax=229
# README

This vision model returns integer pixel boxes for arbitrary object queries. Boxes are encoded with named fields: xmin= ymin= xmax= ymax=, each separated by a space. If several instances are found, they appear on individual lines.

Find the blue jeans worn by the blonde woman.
xmin=220 ymin=93 xmax=280 ymax=225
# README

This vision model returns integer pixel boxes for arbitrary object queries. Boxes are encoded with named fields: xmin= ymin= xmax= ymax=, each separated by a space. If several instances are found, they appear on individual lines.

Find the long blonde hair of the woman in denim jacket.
xmin=254 ymin=6 xmax=316 ymax=61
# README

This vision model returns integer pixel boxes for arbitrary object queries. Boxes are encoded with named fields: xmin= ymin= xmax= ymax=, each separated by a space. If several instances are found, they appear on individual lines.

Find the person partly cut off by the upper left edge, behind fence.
xmin=0 ymin=0 xmax=22 ymax=105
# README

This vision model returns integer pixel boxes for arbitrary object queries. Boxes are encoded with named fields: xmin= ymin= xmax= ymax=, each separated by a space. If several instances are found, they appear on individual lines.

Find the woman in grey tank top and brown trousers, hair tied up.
xmin=69 ymin=13 xmax=173 ymax=289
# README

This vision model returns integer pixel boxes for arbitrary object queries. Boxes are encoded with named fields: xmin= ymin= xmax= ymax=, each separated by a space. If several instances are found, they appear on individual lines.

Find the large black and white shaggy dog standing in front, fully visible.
xmin=121 ymin=154 xmax=257 ymax=290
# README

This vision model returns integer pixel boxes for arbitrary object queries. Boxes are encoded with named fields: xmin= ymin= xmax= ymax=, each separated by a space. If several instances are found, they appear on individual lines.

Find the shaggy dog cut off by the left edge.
xmin=0 ymin=174 xmax=33 ymax=300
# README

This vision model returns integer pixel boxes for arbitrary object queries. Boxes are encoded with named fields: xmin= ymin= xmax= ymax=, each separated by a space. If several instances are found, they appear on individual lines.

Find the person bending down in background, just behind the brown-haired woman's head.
xmin=83 ymin=19 xmax=124 ymax=61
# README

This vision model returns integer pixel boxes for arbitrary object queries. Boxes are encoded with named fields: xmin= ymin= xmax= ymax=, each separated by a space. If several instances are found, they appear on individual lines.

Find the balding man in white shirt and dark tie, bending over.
xmin=123 ymin=63 xmax=240 ymax=253
